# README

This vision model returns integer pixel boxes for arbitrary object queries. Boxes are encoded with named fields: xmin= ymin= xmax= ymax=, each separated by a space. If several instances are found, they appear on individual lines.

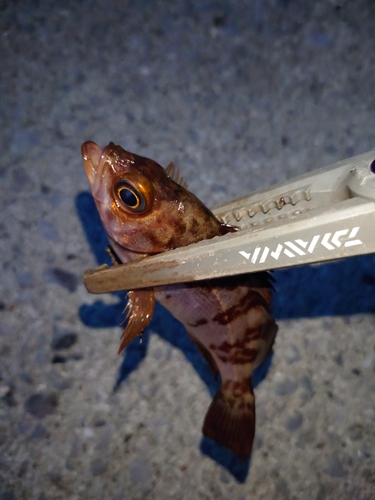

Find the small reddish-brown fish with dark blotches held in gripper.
xmin=81 ymin=141 xmax=278 ymax=460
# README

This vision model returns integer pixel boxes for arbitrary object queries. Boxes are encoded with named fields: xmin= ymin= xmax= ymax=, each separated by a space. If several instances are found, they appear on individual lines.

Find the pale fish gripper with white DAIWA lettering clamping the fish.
xmin=84 ymin=151 xmax=375 ymax=293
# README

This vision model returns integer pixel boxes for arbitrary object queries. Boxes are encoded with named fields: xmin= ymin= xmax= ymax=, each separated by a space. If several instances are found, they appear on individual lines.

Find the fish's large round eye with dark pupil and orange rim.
xmin=115 ymin=176 xmax=152 ymax=213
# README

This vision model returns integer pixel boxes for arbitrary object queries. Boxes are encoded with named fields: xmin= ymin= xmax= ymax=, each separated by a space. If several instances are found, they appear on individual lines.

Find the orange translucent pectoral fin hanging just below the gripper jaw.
xmin=118 ymin=289 xmax=155 ymax=354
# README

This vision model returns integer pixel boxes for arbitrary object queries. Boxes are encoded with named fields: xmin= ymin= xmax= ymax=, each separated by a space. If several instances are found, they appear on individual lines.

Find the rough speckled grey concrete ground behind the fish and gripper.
xmin=0 ymin=0 xmax=375 ymax=500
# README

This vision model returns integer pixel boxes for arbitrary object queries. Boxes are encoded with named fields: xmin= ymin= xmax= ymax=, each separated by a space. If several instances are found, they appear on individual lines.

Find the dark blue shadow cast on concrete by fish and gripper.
xmin=76 ymin=192 xmax=375 ymax=482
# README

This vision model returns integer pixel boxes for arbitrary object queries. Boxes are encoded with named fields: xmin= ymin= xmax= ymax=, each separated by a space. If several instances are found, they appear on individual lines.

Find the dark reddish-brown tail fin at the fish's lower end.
xmin=203 ymin=381 xmax=255 ymax=460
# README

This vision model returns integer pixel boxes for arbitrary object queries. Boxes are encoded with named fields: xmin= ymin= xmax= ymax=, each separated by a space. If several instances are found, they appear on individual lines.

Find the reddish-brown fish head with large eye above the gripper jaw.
xmin=82 ymin=141 xmax=229 ymax=258
